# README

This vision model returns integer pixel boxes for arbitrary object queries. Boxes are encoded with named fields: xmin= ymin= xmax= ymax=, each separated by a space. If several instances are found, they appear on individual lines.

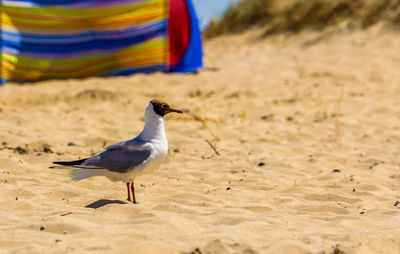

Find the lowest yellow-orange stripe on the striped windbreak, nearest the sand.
xmin=2 ymin=39 xmax=168 ymax=79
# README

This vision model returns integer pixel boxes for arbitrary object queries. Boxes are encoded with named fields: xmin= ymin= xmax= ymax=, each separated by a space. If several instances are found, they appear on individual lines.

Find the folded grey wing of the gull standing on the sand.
xmin=82 ymin=149 xmax=151 ymax=173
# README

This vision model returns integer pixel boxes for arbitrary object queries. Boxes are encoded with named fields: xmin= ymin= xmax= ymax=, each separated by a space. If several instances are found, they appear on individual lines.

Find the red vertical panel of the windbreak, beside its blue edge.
xmin=168 ymin=0 xmax=191 ymax=68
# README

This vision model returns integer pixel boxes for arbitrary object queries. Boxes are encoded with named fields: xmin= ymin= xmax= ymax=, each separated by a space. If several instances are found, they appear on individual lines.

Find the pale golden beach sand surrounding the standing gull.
xmin=0 ymin=27 xmax=400 ymax=254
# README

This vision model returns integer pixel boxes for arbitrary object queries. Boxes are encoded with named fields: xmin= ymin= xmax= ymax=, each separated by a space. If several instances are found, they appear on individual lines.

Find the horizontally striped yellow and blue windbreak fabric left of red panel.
xmin=0 ymin=0 xmax=169 ymax=81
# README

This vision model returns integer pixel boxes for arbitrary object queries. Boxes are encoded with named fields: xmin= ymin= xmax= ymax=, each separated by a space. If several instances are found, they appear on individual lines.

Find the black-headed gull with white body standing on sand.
xmin=53 ymin=99 xmax=182 ymax=204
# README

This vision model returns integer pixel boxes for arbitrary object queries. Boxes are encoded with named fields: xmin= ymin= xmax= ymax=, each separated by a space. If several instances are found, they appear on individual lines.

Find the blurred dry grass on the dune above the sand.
xmin=204 ymin=0 xmax=400 ymax=38
